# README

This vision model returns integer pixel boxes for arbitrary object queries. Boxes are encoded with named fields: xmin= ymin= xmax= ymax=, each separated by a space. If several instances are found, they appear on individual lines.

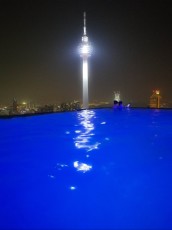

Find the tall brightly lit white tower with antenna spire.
xmin=80 ymin=12 xmax=91 ymax=109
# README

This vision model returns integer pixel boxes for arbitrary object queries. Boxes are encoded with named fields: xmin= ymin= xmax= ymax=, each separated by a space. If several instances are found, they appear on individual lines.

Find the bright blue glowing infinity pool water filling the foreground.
xmin=0 ymin=109 xmax=172 ymax=229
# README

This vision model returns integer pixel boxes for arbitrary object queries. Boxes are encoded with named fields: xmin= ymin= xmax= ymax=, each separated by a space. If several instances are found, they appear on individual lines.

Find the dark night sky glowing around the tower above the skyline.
xmin=0 ymin=0 xmax=172 ymax=105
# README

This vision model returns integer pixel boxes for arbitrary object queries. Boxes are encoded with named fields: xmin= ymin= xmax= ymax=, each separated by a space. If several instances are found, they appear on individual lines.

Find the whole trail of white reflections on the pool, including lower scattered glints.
xmin=48 ymin=110 xmax=101 ymax=191
